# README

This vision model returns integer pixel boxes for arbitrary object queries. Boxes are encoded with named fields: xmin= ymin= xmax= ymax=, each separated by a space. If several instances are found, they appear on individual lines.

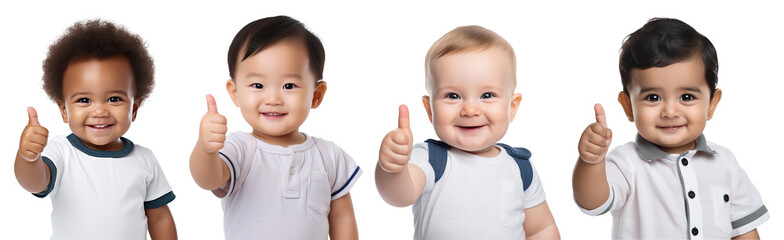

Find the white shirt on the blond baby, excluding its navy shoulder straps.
xmin=409 ymin=143 xmax=545 ymax=240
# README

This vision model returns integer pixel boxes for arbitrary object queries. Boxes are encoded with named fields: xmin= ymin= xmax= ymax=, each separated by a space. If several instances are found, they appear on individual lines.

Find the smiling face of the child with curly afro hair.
xmin=57 ymin=56 xmax=139 ymax=151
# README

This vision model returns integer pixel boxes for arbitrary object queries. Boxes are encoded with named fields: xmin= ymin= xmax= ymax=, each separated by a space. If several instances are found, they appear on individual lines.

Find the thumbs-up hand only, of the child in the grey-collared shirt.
xmin=577 ymin=104 xmax=612 ymax=164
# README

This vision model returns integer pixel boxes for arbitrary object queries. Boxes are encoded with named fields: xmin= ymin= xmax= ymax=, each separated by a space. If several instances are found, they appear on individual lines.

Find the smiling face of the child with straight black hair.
xmin=226 ymin=40 xmax=326 ymax=146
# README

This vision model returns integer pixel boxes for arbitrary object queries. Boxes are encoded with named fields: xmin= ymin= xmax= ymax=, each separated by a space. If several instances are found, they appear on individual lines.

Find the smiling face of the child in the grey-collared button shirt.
xmin=618 ymin=58 xmax=721 ymax=154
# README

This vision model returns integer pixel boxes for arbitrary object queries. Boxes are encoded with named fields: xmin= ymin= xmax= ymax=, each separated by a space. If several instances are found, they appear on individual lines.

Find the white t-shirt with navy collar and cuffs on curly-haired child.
xmin=34 ymin=134 xmax=174 ymax=240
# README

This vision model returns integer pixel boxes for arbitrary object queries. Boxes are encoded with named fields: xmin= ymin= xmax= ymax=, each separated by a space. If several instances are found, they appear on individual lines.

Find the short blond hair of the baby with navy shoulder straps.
xmin=425 ymin=25 xmax=517 ymax=91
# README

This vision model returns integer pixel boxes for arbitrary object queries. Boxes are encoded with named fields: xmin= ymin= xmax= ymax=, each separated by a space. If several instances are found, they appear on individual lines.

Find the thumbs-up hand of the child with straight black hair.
xmin=199 ymin=94 xmax=227 ymax=153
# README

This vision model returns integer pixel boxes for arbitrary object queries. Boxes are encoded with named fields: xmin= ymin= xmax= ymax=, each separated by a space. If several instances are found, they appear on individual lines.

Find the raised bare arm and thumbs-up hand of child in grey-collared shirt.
xmin=572 ymin=104 xmax=612 ymax=209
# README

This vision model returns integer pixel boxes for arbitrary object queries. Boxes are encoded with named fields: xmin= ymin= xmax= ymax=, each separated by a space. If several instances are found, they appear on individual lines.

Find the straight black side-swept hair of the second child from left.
xmin=228 ymin=16 xmax=325 ymax=81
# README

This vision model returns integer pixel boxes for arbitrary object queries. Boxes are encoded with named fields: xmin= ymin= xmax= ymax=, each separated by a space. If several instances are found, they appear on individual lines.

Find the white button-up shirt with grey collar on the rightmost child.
xmin=582 ymin=134 xmax=770 ymax=239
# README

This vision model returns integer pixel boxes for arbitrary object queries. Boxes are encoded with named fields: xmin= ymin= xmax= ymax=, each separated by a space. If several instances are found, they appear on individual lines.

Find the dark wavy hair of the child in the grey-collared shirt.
xmin=619 ymin=18 xmax=719 ymax=98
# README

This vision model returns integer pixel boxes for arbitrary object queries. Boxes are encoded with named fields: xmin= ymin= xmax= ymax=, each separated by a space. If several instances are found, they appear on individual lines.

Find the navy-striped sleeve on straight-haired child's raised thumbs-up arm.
xmin=212 ymin=132 xmax=248 ymax=198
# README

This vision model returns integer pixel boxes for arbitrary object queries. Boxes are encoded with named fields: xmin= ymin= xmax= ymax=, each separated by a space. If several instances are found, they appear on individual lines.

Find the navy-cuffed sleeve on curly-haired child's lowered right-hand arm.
xmin=144 ymin=148 xmax=175 ymax=209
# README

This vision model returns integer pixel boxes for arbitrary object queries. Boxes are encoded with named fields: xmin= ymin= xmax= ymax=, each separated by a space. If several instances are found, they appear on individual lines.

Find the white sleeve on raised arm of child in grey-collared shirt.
xmin=578 ymin=146 xmax=629 ymax=216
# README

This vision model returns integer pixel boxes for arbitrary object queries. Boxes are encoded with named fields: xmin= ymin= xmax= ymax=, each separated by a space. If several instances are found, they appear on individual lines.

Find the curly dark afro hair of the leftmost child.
xmin=43 ymin=19 xmax=155 ymax=102
